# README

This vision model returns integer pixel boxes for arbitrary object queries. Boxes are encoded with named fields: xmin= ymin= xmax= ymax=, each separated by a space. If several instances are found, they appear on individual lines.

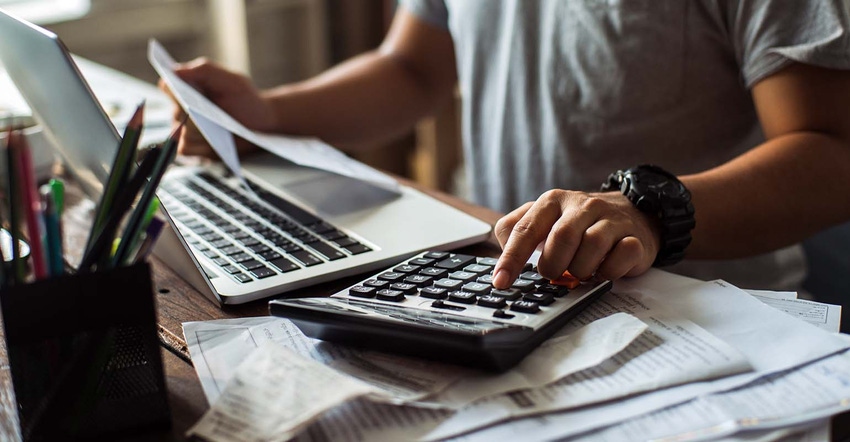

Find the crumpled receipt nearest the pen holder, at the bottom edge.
xmin=187 ymin=344 xmax=374 ymax=442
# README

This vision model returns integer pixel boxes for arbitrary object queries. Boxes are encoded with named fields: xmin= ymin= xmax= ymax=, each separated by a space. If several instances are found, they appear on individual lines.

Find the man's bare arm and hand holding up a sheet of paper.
xmin=167 ymin=8 xmax=457 ymax=154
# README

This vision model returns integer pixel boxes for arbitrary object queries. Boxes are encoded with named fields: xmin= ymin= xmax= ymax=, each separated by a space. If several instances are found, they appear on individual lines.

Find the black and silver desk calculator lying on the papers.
xmin=269 ymin=251 xmax=612 ymax=372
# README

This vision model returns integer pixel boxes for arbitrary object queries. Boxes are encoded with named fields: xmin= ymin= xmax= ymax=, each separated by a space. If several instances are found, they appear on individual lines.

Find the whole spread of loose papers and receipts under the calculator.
xmin=183 ymin=269 xmax=850 ymax=441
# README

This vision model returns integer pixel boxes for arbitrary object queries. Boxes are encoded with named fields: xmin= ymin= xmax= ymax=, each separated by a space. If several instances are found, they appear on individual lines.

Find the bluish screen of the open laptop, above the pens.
xmin=0 ymin=10 xmax=120 ymax=199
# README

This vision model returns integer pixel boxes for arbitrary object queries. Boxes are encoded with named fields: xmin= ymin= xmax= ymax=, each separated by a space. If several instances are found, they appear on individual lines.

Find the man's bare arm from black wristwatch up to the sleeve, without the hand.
xmin=680 ymin=64 xmax=850 ymax=258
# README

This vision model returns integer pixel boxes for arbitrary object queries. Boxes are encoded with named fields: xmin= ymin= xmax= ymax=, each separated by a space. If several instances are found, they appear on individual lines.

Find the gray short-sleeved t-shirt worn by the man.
xmin=401 ymin=0 xmax=850 ymax=289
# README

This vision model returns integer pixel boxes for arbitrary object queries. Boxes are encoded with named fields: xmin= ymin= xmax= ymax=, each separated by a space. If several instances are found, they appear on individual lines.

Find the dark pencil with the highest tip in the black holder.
xmin=86 ymin=101 xmax=145 ymax=254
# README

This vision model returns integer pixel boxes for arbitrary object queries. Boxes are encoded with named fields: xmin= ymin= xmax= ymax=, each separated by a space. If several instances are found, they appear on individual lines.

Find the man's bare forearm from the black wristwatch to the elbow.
xmin=681 ymin=132 xmax=850 ymax=258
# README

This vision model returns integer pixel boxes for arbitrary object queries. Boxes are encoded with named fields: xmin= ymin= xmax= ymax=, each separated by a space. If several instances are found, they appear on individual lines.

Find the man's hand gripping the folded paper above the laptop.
xmin=159 ymin=58 xmax=275 ymax=157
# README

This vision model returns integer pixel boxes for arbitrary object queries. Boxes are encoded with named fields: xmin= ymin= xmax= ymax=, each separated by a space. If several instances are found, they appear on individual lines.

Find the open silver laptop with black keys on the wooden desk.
xmin=0 ymin=10 xmax=491 ymax=304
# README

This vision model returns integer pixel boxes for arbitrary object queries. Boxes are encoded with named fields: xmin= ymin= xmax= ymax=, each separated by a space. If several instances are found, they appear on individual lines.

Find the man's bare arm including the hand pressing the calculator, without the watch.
xmin=486 ymin=64 xmax=850 ymax=287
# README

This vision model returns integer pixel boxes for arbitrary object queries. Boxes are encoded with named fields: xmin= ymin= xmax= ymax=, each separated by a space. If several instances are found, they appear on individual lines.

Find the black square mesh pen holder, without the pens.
xmin=0 ymin=264 xmax=171 ymax=441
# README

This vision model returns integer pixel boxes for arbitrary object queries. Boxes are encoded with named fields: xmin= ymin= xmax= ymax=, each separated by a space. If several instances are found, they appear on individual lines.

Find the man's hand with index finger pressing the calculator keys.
xmin=493 ymin=190 xmax=660 ymax=289
